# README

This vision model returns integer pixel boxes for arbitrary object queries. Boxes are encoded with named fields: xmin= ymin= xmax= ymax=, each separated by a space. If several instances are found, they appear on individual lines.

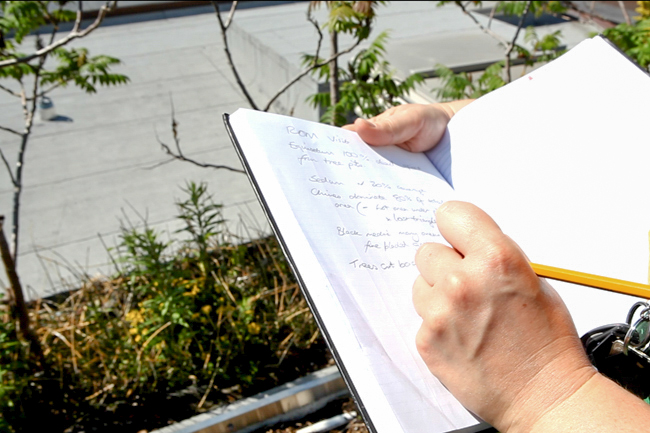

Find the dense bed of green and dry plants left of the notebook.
xmin=0 ymin=183 xmax=328 ymax=431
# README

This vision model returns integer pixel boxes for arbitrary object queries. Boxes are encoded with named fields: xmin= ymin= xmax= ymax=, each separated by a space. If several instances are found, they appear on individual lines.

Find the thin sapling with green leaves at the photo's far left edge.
xmin=0 ymin=1 xmax=128 ymax=362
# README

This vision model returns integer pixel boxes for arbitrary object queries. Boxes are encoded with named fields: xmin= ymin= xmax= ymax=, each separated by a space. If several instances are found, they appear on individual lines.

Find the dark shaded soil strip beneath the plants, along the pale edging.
xmin=11 ymin=339 xmax=334 ymax=433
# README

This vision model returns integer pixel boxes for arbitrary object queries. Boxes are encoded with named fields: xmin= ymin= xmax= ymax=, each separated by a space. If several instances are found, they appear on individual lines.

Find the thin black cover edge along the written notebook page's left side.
xmin=223 ymin=113 xmax=378 ymax=433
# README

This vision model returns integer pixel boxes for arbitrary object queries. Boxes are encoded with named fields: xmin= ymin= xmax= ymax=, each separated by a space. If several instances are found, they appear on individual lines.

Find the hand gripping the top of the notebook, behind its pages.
xmin=343 ymin=99 xmax=472 ymax=152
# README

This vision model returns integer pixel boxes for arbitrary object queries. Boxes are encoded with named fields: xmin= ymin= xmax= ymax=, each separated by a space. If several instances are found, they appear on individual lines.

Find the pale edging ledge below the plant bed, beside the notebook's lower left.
xmin=152 ymin=366 xmax=348 ymax=433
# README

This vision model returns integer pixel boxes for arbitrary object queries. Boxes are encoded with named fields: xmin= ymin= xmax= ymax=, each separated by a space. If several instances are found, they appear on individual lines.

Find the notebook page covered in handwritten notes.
xmin=230 ymin=110 xmax=477 ymax=433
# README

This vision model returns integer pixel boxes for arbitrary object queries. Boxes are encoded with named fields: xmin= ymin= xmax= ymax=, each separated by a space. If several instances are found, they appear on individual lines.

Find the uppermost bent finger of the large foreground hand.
xmin=436 ymin=201 xmax=512 ymax=257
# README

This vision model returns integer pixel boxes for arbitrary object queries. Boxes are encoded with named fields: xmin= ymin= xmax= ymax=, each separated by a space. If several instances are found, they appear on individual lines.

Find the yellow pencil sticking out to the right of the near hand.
xmin=530 ymin=263 xmax=650 ymax=299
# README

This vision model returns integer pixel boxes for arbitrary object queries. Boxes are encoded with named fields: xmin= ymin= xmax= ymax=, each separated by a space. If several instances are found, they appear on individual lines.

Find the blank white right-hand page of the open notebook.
xmin=436 ymin=38 xmax=650 ymax=334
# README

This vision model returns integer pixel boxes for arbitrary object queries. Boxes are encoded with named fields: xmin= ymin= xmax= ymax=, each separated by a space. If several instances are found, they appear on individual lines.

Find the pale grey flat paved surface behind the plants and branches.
xmin=0 ymin=2 xmax=597 ymax=298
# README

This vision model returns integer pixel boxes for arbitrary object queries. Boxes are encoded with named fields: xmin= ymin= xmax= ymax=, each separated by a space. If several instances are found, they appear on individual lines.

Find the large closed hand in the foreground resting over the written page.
xmin=413 ymin=202 xmax=596 ymax=432
